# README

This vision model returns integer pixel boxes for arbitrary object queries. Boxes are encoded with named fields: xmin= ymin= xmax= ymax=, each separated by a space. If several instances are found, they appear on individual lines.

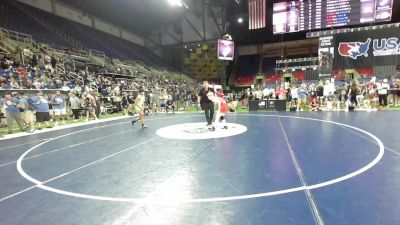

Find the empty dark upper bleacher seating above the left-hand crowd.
xmin=0 ymin=0 xmax=168 ymax=68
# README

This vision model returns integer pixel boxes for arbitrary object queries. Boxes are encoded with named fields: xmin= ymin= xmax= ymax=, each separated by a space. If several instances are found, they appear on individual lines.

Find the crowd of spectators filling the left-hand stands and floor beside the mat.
xmin=0 ymin=51 xmax=197 ymax=134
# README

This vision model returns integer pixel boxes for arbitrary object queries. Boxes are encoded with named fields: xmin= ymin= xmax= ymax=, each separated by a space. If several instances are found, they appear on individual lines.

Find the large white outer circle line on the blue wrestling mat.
xmin=17 ymin=114 xmax=385 ymax=204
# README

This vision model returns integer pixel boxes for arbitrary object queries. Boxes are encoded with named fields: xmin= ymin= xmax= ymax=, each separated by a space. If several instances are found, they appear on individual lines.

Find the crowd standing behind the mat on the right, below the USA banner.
xmin=235 ymin=77 xmax=400 ymax=111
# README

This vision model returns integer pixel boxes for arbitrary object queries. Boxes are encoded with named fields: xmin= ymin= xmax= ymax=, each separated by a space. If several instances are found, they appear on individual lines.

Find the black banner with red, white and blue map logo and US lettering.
xmin=333 ymin=27 xmax=400 ymax=69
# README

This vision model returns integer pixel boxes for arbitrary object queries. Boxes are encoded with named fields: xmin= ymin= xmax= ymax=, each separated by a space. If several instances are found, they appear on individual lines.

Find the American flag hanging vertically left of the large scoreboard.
xmin=249 ymin=0 xmax=267 ymax=30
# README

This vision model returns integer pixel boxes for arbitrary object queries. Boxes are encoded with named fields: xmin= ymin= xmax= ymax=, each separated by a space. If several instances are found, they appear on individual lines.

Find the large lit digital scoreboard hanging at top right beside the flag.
xmin=272 ymin=0 xmax=393 ymax=34
